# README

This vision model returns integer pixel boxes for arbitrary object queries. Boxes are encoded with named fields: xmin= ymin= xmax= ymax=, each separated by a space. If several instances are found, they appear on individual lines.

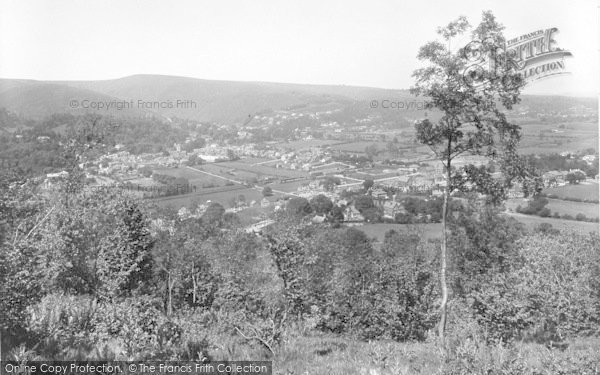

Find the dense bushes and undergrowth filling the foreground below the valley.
xmin=0 ymin=167 xmax=600 ymax=374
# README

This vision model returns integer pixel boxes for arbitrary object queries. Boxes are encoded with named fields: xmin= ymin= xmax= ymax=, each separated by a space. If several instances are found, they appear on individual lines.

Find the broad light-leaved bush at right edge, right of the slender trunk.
xmin=471 ymin=232 xmax=600 ymax=342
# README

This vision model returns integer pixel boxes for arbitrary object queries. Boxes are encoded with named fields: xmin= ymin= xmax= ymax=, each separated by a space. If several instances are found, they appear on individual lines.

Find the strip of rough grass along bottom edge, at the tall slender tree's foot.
xmin=273 ymin=334 xmax=600 ymax=375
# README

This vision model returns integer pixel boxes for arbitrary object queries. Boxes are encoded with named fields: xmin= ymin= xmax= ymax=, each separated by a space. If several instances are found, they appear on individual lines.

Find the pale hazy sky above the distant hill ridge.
xmin=0 ymin=0 xmax=600 ymax=96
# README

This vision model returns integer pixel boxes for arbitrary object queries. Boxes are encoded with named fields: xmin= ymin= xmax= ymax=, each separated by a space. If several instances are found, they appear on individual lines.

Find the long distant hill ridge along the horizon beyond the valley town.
xmin=0 ymin=75 xmax=596 ymax=124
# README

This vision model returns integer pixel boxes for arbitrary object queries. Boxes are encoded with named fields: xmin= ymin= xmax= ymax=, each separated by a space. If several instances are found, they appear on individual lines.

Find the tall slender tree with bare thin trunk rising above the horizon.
xmin=411 ymin=12 xmax=524 ymax=345
